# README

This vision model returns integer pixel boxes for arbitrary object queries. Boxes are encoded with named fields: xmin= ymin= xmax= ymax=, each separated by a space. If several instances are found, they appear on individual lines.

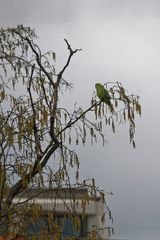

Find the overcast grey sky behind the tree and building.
xmin=0 ymin=0 xmax=160 ymax=240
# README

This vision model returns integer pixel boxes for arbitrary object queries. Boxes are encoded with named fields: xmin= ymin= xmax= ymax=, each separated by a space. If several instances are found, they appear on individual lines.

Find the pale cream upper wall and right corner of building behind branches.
xmin=14 ymin=189 xmax=107 ymax=239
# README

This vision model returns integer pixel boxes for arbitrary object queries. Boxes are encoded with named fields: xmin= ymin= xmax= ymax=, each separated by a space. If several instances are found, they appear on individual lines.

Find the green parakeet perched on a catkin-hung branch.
xmin=95 ymin=83 xmax=113 ymax=110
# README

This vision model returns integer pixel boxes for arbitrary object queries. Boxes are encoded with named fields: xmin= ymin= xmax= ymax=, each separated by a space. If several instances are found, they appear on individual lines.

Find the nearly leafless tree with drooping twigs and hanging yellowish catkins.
xmin=0 ymin=25 xmax=141 ymax=239
